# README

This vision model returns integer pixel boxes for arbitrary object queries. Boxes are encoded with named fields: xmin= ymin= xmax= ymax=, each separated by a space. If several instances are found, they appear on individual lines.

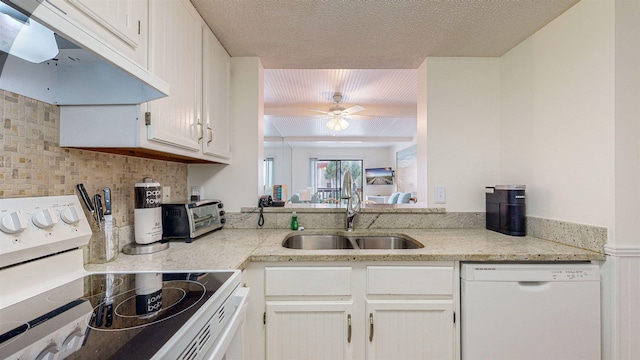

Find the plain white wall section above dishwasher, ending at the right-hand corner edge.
xmin=500 ymin=0 xmax=615 ymax=229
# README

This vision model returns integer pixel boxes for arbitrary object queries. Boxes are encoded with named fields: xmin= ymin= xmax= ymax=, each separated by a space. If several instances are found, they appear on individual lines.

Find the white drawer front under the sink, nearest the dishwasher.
xmin=367 ymin=266 xmax=453 ymax=295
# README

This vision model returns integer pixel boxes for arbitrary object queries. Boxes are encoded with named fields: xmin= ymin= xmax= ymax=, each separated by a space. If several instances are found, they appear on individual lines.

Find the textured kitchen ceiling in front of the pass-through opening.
xmin=191 ymin=0 xmax=579 ymax=69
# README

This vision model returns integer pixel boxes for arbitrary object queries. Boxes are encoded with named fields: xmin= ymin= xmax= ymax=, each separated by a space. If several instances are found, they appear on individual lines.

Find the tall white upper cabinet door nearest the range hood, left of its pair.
xmin=147 ymin=0 xmax=203 ymax=153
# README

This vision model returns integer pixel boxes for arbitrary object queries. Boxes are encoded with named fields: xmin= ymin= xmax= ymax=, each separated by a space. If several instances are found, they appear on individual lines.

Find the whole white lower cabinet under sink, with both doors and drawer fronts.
xmin=248 ymin=262 xmax=459 ymax=360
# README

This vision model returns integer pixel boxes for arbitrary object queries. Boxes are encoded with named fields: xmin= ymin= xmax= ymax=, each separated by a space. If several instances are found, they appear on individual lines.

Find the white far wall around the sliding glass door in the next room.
xmin=289 ymin=147 xmax=396 ymax=195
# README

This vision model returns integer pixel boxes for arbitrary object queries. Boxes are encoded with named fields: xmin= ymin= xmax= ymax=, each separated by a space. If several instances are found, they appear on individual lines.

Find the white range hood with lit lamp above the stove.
xmin=0 ymin=0 xmax=169 ymax=105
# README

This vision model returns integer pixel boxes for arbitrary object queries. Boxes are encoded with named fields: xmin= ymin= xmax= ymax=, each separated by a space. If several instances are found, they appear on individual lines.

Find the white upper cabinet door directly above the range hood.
xmin=66 ymin=0 xmax=148 ymax=67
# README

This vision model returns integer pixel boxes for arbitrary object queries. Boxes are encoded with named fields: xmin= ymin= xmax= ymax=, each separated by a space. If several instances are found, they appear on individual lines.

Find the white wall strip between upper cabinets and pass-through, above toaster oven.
xmin=187 ymin=57 xmax=264 ymax=211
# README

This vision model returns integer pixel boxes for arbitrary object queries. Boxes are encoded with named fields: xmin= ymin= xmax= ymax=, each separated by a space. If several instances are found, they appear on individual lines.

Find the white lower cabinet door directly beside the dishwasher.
xmin=366 ymin=300 xmax=454 ymax=360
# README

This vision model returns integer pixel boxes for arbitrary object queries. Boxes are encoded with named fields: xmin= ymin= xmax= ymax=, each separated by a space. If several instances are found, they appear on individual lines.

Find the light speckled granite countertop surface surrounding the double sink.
xmin=85 ymin=229 xmax=605 ymax=271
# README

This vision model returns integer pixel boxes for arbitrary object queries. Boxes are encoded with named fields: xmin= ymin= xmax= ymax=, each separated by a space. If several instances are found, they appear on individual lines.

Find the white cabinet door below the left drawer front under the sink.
xmin=266 ymin=301 xmax=353 ymax=360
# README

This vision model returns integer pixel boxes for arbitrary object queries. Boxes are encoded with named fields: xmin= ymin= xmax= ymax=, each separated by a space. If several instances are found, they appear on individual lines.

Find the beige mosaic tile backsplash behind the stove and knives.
xmin=0 ymin=90 xmax=187 ymax=262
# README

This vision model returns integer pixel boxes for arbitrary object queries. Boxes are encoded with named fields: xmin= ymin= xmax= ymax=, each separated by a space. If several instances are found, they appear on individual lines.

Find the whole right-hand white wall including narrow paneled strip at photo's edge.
xmin=501 ymin=0 xmax=640 ymax=359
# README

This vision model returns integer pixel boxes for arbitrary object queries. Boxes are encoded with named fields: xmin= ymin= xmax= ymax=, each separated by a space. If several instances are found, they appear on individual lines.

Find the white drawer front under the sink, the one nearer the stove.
xmin=265 ymin=267 xmax=351 ymax=296
